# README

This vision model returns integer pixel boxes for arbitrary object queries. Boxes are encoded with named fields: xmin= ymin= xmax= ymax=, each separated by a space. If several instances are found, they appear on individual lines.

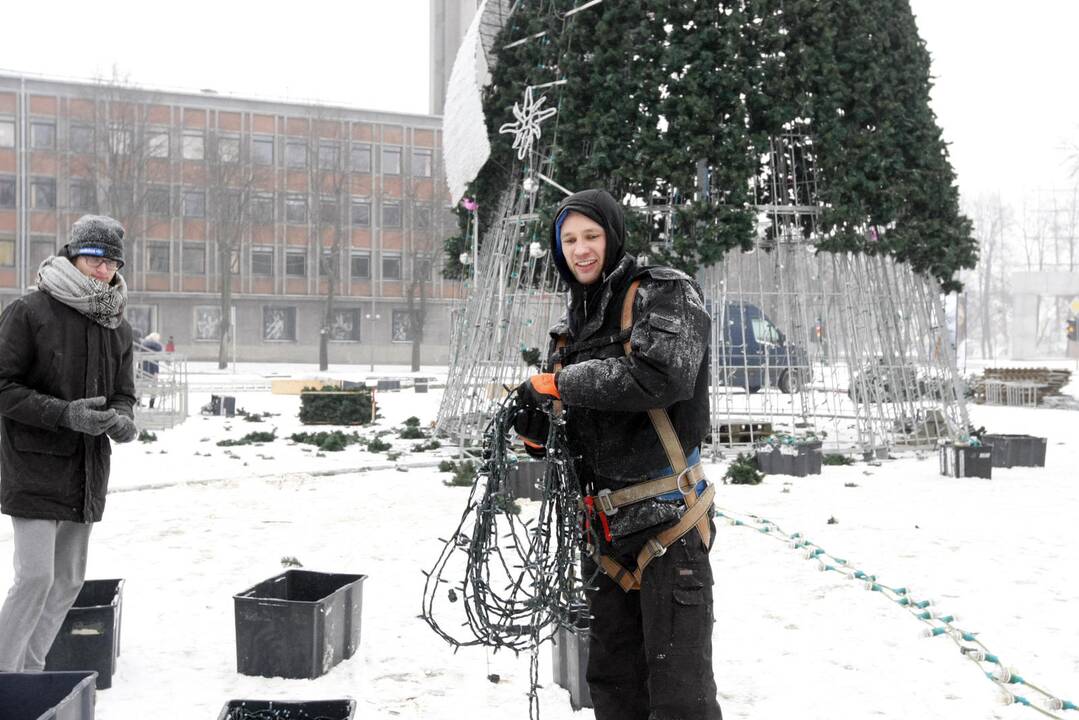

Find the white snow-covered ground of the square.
xmin=0 ymin=364 xmax=1079 ymax=720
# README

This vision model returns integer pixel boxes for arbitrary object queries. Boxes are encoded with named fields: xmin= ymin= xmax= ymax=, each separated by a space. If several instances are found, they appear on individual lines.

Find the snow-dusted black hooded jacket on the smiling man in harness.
xmin=548 ymin=190 xmax=711 ymax=481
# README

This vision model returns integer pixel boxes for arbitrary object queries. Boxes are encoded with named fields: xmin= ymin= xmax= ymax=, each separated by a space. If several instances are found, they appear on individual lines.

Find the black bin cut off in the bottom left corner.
xmin=0 ymin=671 xmax=97 ymax=720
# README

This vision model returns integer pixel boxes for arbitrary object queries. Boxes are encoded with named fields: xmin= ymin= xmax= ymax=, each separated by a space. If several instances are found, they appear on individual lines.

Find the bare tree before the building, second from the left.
xmin=205 ymin=128 xmax=267 ymax=369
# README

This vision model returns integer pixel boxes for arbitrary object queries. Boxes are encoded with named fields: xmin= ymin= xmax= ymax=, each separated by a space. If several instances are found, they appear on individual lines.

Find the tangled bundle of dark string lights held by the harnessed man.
xmin=423 ymin=393 xmax=599 ymax=717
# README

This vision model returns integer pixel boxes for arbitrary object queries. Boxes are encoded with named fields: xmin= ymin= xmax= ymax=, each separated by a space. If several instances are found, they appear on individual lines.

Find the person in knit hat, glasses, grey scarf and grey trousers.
xmin=0 ymin=215 xmax=138 ymax=673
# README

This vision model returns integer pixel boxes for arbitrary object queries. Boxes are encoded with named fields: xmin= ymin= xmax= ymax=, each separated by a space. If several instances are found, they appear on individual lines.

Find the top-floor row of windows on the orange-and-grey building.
xmin=0 ymin=118 xmax=434 ymax=177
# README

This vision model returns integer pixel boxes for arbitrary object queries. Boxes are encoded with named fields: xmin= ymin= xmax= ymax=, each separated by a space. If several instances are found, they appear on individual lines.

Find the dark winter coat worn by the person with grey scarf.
xmin=0 ymin=290 xmax=135 ymax=522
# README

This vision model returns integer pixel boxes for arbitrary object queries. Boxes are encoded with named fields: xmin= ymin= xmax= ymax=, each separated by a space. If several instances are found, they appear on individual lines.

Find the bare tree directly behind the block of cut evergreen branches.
xmin=308 ymin=109 xmax=351 ymax=370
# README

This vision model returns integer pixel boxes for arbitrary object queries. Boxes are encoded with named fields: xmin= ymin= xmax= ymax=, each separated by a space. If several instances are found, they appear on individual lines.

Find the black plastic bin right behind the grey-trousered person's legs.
xmin=45 ymin=580 xmax=124 ymax=690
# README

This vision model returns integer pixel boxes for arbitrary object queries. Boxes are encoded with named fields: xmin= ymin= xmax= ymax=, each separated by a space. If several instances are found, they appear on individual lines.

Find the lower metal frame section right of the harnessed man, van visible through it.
xmin=701 ymin=242 xmax=968 ymax=452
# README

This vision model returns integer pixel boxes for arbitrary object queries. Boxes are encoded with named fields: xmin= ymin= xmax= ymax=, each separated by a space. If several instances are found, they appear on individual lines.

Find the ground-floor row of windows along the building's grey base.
xmin=125 ymin=304 xmax=413 ymax=342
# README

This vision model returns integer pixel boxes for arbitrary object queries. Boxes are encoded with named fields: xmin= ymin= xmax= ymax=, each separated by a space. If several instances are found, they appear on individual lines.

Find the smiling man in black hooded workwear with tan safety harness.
xmin=515 ymin=190 xmax=722 ymax=720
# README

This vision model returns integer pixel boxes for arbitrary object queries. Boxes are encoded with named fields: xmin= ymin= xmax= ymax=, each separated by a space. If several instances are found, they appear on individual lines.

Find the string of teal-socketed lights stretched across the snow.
xmin=715 ymin=507 xmax=1079 ymax=720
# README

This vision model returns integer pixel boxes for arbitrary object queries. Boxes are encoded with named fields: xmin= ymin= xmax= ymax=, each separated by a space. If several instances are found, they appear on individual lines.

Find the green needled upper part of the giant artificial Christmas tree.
xmin=448 ymin=0 xmax=976 ymax=290
